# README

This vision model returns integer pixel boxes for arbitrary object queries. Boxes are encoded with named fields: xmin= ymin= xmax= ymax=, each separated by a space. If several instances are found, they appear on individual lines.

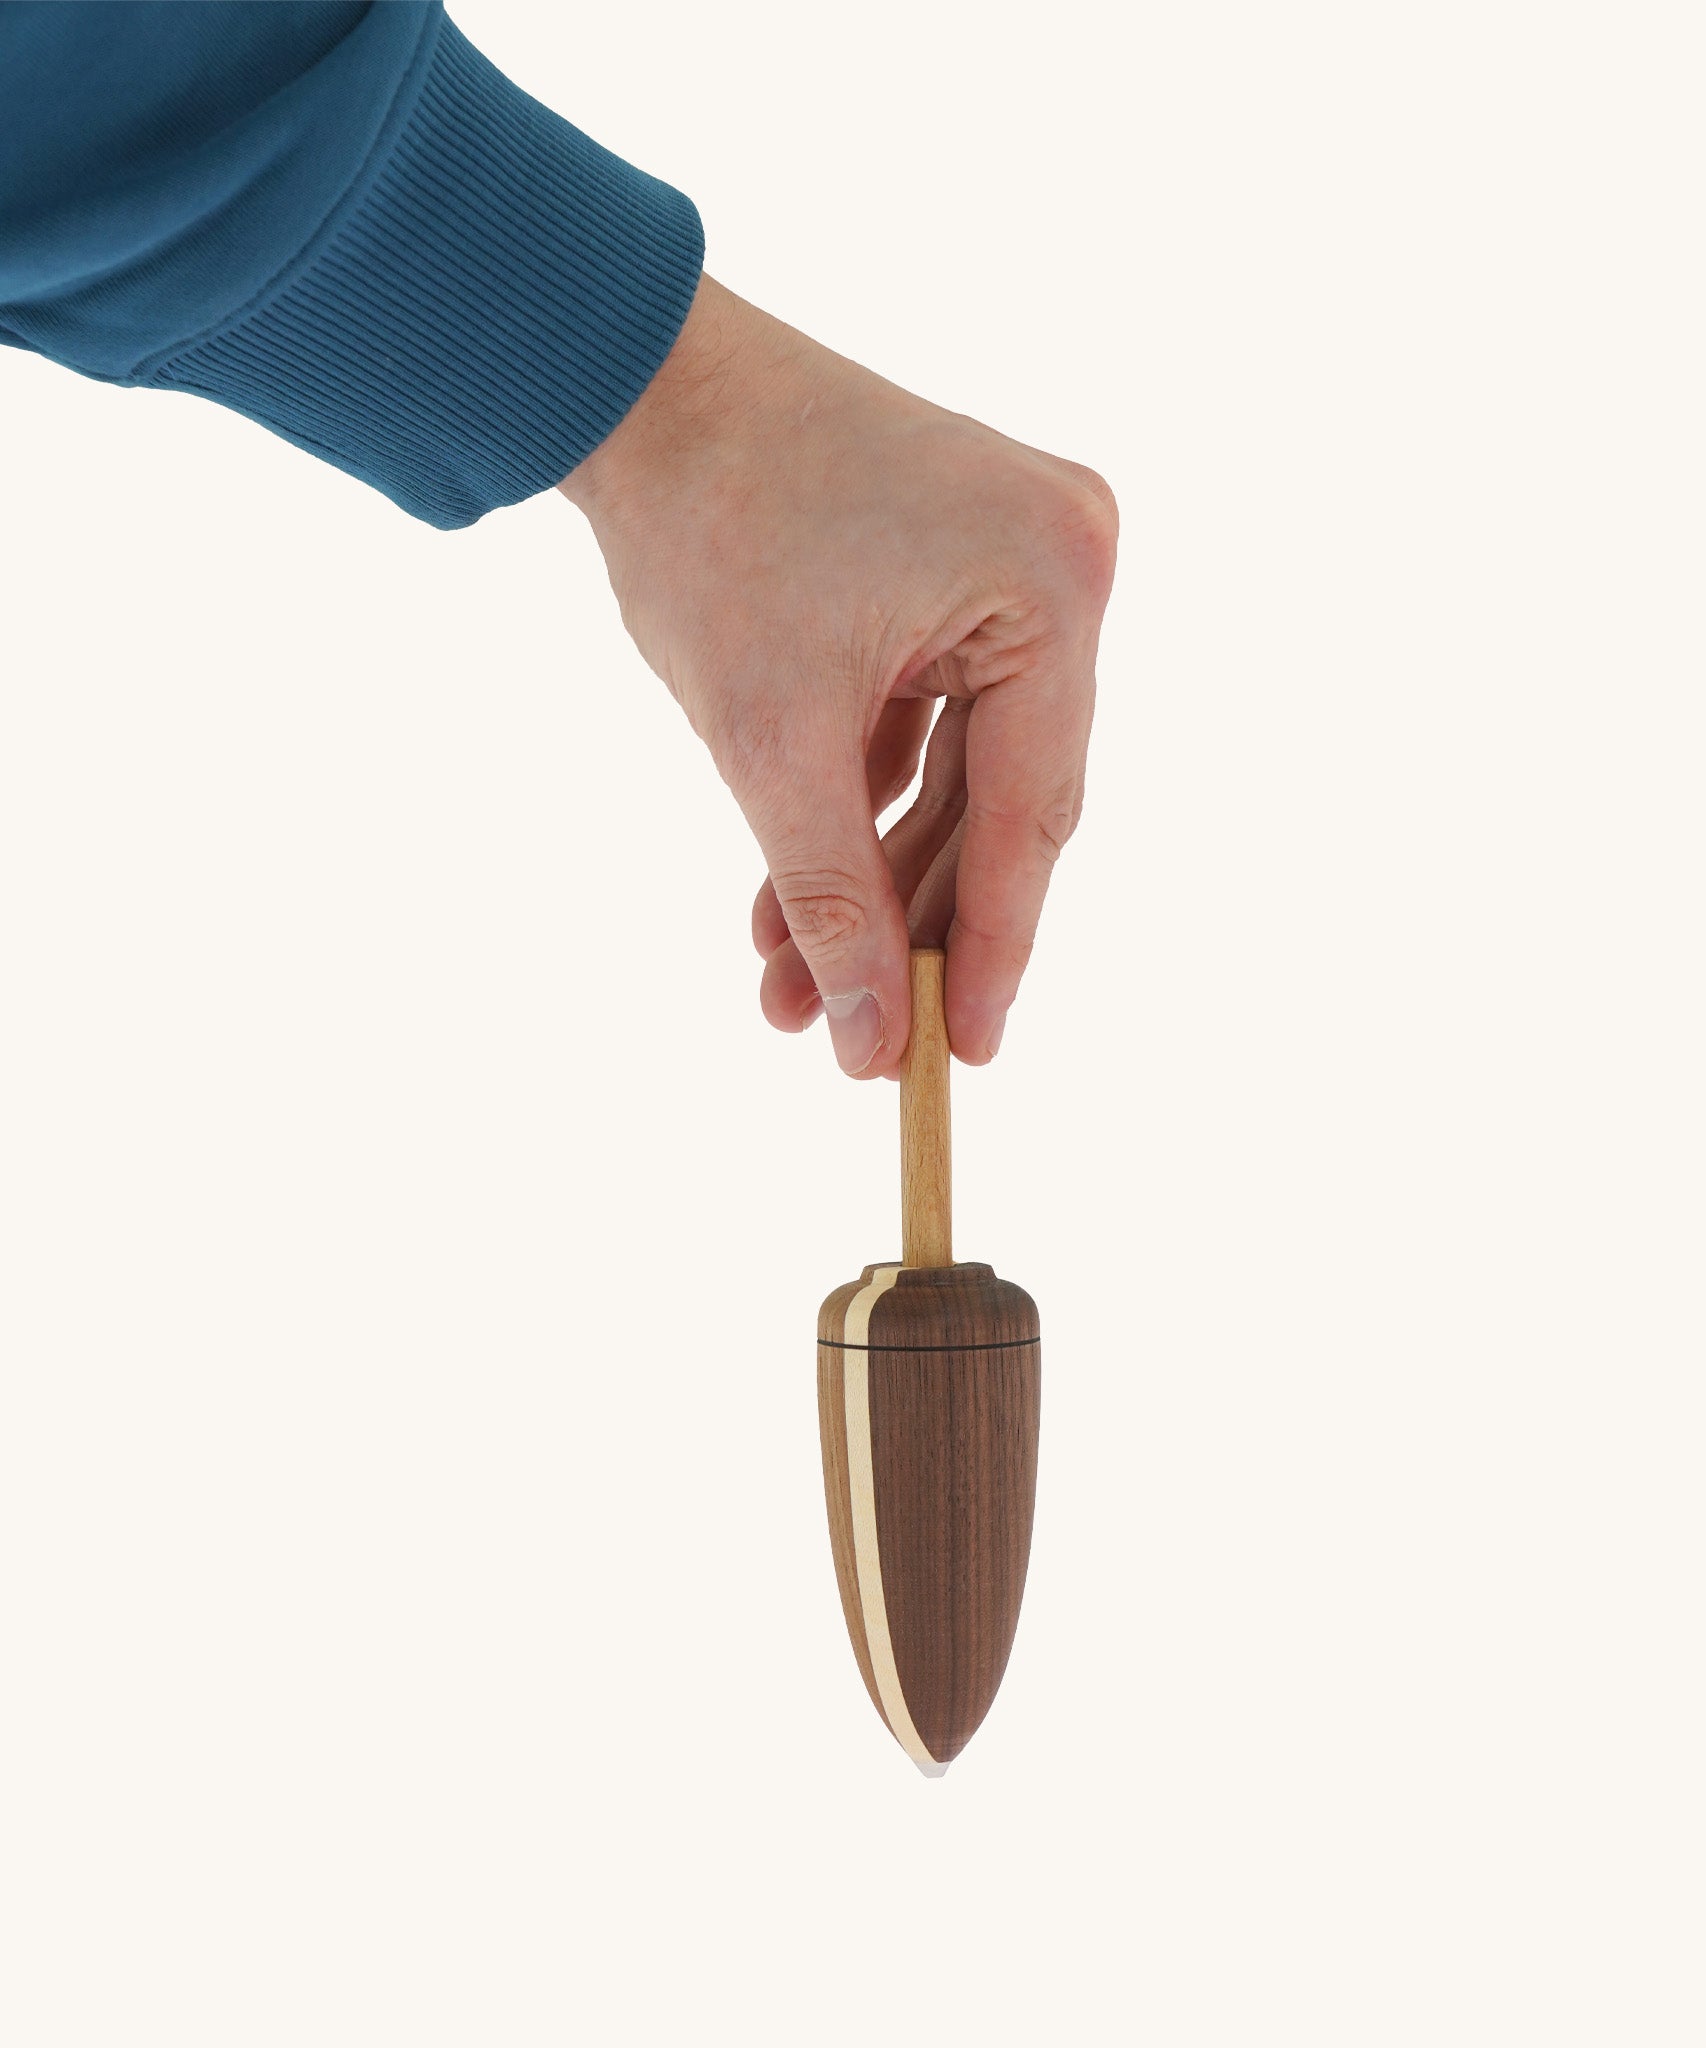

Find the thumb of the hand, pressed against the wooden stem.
xmin=745 ymin=758 xmax=911 ymax=1079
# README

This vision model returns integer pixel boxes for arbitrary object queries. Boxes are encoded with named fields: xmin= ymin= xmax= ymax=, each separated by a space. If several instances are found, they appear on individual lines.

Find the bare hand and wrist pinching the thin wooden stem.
xmin=559 ymin=276 xmax=1118 ymax=1079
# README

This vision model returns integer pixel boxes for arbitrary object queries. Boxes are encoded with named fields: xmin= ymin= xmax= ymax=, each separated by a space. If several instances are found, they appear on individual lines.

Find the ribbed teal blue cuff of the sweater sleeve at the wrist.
xmin=135 ymin=18 xmax=705 ymax=526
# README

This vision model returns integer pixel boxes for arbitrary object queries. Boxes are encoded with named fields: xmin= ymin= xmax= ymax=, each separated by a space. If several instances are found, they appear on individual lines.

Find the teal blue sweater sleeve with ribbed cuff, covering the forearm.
xmin=0 ymin=0 xmax=705 ymax=526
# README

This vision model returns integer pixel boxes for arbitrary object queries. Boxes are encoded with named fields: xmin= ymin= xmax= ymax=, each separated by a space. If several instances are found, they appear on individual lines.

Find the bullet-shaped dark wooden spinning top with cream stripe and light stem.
xmin=817 ymin=948 xmax=1040 ymax=1778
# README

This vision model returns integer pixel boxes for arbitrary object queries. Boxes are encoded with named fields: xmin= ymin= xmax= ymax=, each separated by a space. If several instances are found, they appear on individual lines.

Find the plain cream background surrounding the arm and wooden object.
xmin=0 ymin=0 xmax=1706 ymax=2048
